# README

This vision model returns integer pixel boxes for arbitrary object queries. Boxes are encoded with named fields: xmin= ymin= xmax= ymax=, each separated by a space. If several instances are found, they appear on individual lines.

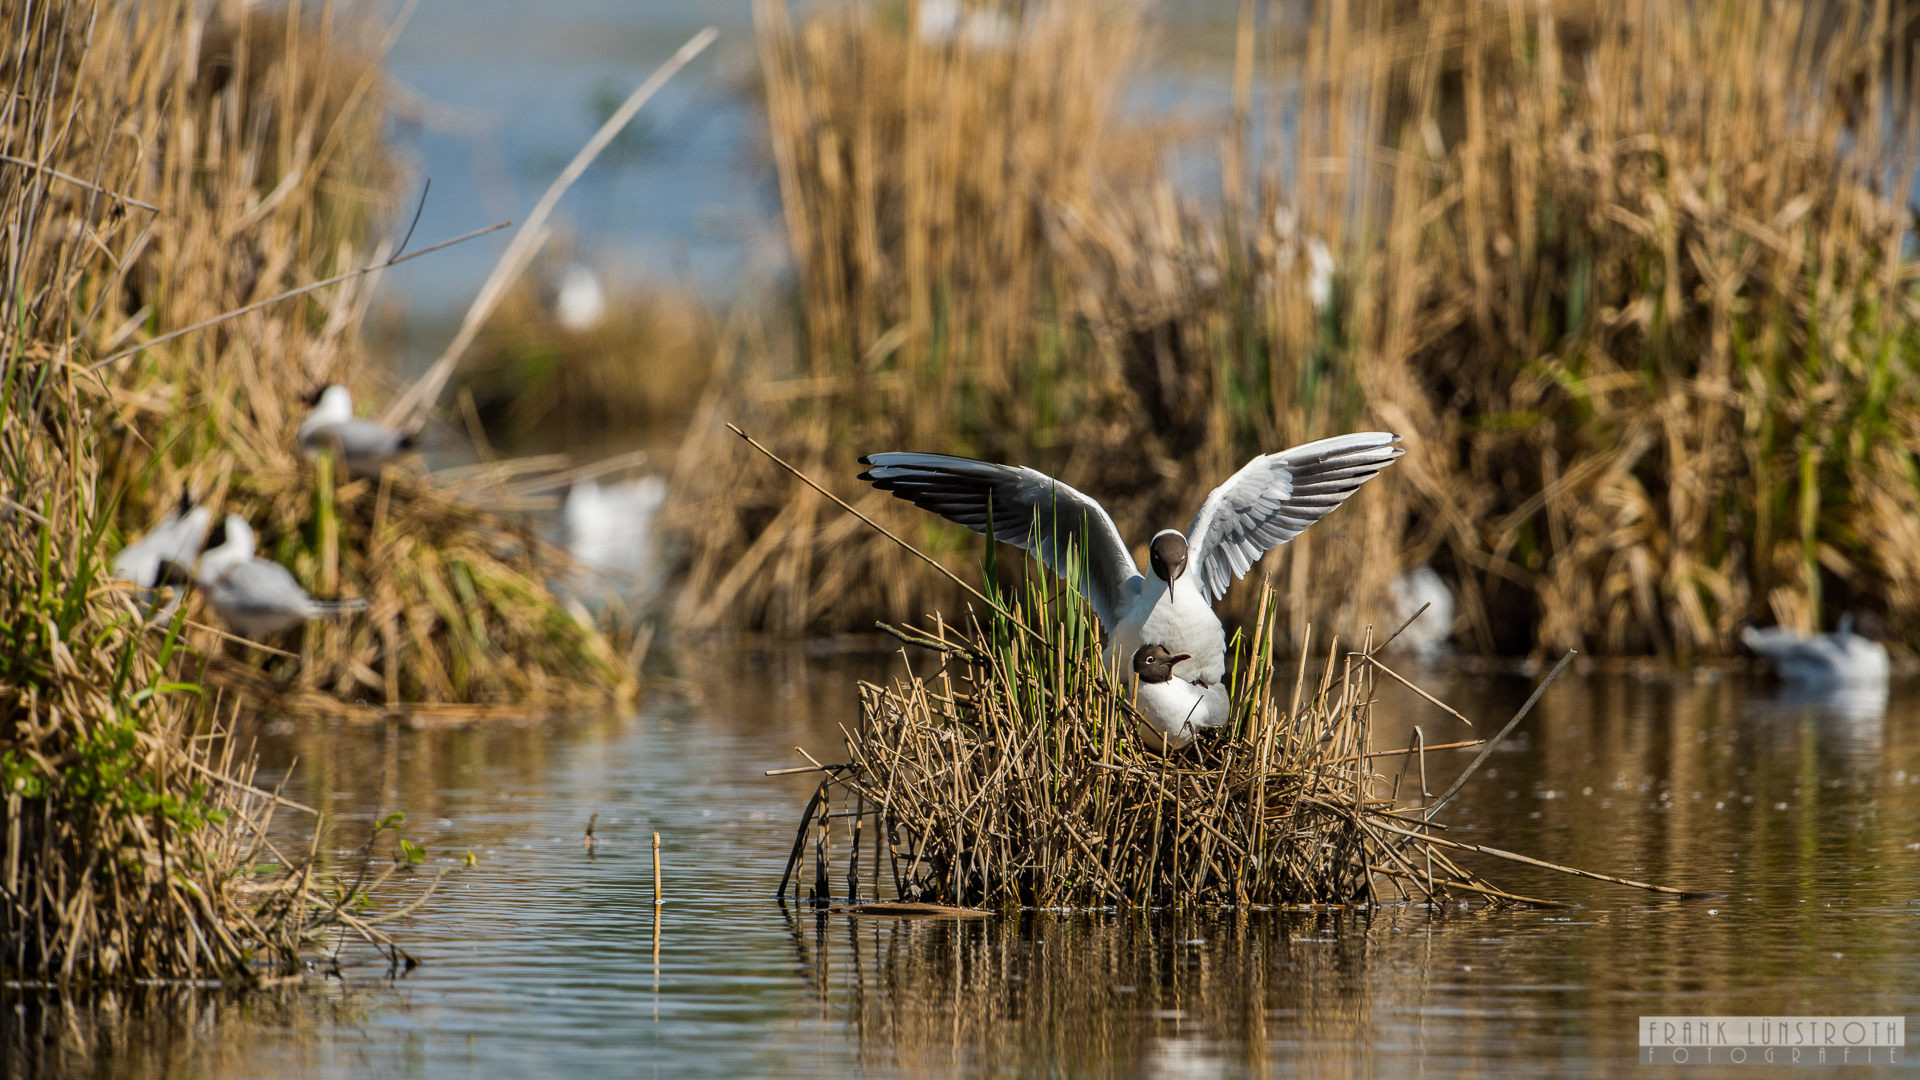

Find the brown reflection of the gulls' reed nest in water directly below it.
xmin=793 ymin=913 xmax=1390 ymax=1076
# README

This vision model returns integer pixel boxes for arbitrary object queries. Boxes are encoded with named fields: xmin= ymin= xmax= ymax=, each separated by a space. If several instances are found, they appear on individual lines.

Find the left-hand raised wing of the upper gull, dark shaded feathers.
xmin=860 ymin=454 xmax=1140 ymax=630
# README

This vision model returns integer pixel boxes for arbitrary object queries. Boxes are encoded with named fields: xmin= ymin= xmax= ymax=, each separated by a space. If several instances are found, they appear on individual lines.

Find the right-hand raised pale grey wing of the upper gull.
xmin=1187 ymin=430 xmax=1405 ymax=603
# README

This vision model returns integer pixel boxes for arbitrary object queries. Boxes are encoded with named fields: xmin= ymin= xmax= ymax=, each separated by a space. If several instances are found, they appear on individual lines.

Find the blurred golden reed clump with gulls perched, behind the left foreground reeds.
xmin=39 ymin=2 xmax=634 ymax=715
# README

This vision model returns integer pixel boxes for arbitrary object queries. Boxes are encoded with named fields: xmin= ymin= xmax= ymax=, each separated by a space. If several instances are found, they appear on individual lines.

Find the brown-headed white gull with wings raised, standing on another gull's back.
xmin=860 ymin=430 xmax=1405 ymax=684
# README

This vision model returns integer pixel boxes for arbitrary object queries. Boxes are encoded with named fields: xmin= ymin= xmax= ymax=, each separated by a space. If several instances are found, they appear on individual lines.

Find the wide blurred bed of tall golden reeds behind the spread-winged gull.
xmin=680 ymin=0 xmax=1920 ymax=661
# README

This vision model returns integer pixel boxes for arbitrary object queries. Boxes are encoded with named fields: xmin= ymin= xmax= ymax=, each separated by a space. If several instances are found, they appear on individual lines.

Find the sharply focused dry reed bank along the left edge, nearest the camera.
xmin=0 ymin=4 xmax=449 ymax=984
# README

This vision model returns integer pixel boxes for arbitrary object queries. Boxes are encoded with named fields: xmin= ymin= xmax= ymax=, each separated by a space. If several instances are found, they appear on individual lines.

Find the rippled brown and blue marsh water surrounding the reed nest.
xmin=0 ymin=650 xmax=1920 ymax=1078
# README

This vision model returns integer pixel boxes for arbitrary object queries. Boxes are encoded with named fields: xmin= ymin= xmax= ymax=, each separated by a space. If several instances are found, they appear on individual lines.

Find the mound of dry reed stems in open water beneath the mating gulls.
xmin=781 ymin=572 xmax=1605 ymax=911
